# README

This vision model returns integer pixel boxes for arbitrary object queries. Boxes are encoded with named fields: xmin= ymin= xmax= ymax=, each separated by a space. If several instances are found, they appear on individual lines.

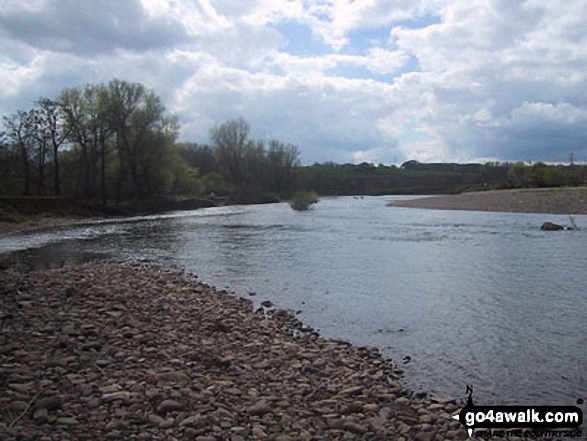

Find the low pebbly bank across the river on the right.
xmin=388 ymin=187 xmax=587 ymax=215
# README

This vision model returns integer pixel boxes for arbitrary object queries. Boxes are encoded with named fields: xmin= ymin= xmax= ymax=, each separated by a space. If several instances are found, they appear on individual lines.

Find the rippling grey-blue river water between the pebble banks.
xmin=0 ymin=196 xmax=587 ymax=405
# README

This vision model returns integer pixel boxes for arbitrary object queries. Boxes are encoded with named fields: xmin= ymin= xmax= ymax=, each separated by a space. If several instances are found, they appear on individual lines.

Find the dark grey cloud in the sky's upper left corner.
xmin=0 ymin=0 xmax=188 ymax=57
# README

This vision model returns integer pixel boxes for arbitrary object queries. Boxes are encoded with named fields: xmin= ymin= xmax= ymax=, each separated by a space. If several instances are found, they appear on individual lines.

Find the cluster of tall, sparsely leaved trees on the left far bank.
xmin=0 ymin=79 xmax=299 ymax=205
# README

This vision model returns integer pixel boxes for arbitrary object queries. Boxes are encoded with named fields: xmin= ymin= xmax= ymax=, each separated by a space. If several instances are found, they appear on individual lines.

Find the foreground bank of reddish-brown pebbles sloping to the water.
xmin=0 ymin=264 xmax=466 ymax=441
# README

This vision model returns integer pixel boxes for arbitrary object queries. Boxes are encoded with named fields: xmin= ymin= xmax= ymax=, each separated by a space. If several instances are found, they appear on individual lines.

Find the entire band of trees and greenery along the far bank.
xmin=0 ymin=79 xmax=587 ymax=217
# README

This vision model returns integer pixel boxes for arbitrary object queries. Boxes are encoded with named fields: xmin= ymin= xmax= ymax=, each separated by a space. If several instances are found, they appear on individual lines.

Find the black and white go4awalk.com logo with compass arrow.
xmin=453 ymin=385 xmax=583 ymax=438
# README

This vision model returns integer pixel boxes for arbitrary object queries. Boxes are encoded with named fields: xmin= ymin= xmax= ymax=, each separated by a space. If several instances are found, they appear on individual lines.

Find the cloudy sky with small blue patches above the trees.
xmin=0 ymin=0 xmax=587 ymax=164
